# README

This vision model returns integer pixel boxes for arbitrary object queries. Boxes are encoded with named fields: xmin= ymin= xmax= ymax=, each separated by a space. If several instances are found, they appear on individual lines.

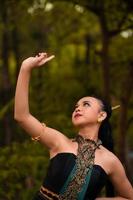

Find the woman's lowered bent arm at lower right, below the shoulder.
xmin=96 ymin=155 xmax=133 ymax=200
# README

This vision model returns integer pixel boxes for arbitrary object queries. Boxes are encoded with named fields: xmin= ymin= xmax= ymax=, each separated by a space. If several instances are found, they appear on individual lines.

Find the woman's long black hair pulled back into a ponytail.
xmin=92 ymin=96 xmax=114 ymax=197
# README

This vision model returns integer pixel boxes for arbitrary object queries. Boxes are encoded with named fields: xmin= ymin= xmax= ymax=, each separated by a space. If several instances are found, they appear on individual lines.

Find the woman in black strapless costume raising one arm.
xmin=15 ymin=53 xmax=133 ymax=200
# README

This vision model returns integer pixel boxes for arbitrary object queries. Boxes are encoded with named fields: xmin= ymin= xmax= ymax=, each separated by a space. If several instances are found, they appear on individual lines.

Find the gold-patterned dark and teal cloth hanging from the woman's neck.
xmin=59 ymin=135 xmax=102 ymax=200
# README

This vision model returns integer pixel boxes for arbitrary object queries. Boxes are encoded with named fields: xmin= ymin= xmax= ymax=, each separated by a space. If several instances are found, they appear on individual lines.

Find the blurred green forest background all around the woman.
xmin=0 ymin=0 xmax=133 ymax=200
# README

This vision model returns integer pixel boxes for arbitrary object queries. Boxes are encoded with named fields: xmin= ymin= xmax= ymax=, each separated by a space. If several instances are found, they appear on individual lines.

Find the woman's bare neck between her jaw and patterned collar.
xmin=79 ymin=125 xmax=99 ymax=141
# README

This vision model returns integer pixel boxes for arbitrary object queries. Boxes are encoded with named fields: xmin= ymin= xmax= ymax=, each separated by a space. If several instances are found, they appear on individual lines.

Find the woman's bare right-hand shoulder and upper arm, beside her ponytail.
xmin=96 ymin=146 xmax=133 ymax=199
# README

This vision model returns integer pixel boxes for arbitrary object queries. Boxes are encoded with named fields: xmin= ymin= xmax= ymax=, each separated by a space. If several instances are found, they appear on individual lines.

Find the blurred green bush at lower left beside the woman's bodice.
xmin=0 ymin=141 xmax=48 ymax=200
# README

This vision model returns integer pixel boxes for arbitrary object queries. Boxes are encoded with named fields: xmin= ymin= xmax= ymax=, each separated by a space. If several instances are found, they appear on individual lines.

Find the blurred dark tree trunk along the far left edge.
xmin=1 ymin=1 xmax=12 ymax=145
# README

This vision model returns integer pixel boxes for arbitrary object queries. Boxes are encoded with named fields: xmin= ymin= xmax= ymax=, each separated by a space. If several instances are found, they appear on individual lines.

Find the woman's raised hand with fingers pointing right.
xmin=22 ymin=53 xmax=55 ymax=69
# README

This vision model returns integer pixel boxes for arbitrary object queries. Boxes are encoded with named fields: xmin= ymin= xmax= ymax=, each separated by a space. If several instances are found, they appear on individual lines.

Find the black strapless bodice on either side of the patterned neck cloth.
xmin=34 ymin=153 xmax=107 ymax=200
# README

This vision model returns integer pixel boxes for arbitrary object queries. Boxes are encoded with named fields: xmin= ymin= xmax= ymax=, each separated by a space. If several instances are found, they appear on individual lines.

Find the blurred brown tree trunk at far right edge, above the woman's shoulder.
xmin=118 ymin=63 xmax=133 ymax=174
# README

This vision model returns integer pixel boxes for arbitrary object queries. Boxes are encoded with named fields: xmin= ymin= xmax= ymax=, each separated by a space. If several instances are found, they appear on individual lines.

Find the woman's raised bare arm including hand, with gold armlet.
xmin=14 ymin=53 xmax=68 ymax=152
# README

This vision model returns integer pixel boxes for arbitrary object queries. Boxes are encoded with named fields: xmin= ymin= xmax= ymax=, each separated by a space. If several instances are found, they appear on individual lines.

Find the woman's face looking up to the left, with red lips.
xmin=72 ymin=97 xmax=101 ymax=127
